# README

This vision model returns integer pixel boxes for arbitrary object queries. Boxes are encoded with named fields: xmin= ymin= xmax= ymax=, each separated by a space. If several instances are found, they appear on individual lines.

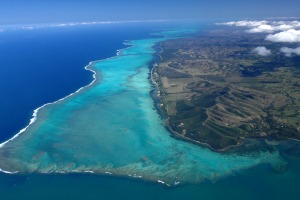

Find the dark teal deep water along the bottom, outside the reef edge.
xmin=0 ymin=159 xmax=300 ymax=200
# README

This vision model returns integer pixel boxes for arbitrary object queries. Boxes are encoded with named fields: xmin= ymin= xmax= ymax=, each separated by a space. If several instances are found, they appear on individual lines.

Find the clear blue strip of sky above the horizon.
xmin=0 ymin=0 xmax=300 ymax=25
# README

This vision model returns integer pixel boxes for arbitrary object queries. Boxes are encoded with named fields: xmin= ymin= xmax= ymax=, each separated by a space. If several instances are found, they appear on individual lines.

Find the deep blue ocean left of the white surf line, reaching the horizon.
xmin=0 ymin=23 xmax=163 ymax=142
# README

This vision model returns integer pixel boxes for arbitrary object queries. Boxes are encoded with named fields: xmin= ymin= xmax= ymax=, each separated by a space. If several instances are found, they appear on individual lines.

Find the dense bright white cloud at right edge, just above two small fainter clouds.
xmin=266 ymin=29 xmax=300 ymax=43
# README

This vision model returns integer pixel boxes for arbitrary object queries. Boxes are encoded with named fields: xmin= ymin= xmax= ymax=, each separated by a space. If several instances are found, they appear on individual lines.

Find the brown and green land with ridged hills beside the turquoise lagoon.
xmin=152 ymin=27 xmax=300 ymax=150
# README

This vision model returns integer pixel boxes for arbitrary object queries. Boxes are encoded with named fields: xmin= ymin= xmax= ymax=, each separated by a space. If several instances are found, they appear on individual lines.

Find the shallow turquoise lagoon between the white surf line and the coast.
xmin=0 ymin=27 xmax=286 ymax=185
